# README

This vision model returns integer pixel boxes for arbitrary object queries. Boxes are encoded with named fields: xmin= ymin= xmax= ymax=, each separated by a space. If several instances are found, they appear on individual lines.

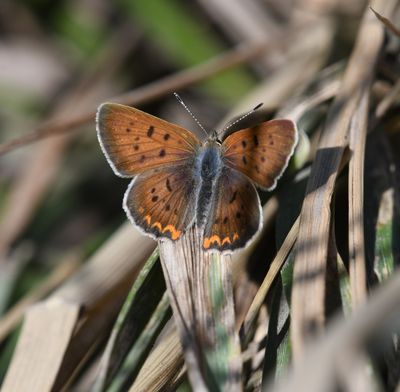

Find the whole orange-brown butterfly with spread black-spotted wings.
xmin=97 ymin=103 xmax=297 ymax=253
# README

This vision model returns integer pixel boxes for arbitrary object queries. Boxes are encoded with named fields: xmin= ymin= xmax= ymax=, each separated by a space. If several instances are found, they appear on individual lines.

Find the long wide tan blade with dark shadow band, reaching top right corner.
xmin=291 ymin=0 xmax=396 ymax=358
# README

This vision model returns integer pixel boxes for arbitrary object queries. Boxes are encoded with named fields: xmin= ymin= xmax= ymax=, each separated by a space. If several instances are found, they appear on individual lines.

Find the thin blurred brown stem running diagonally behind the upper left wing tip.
xmin=0 ymin=42 xmax=269 ymax=156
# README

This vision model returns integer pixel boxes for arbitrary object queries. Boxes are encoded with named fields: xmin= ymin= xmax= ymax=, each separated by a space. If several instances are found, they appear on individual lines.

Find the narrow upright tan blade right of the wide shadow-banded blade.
xmin=349 ymin=85 xmax=370 ymax=307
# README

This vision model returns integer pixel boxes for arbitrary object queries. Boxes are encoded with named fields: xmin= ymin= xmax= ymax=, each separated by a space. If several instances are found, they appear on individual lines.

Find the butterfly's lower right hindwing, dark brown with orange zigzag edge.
xmin=203 ymin=167 xmax=261 ymax=252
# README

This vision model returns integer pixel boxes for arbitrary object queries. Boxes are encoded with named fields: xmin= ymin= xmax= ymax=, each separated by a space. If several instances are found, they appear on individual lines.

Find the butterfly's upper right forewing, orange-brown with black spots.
xmin=223 ymin=120 xmax=297 ymax=190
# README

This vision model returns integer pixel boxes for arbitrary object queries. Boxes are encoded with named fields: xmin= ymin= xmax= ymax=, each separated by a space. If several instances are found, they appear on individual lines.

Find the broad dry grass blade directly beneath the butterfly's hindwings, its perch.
xmin=160 ymin=227 xmax=241 ymax=391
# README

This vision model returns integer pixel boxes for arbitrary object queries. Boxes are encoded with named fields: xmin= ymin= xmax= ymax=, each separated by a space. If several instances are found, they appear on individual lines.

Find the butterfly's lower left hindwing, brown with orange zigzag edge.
xmin=123 ymin=165 xmax=197 ymax=241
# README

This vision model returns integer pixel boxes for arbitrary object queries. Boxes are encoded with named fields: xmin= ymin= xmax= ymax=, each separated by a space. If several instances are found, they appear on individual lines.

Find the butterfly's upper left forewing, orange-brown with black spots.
xmin=97 ymin=103 xmax=200 ymax=177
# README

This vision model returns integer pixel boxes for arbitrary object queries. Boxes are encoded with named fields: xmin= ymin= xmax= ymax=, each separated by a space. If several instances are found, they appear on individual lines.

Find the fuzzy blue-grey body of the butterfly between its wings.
xmin=194 ymin=143 xmax=222 ymax=227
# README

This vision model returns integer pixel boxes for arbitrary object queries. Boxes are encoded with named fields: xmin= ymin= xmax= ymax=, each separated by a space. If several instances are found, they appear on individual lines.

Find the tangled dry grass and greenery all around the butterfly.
xmin=0 ymin=0 xmax=400 ymax=392
